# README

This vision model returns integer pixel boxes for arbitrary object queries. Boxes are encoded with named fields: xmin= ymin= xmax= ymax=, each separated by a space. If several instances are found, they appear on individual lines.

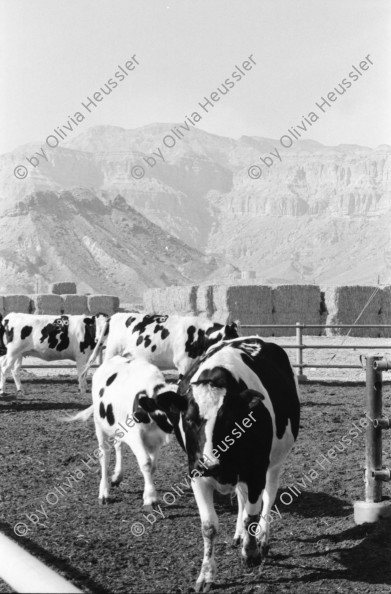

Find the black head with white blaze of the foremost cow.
xmin=141 ymin=358 xmax=264 ymax=474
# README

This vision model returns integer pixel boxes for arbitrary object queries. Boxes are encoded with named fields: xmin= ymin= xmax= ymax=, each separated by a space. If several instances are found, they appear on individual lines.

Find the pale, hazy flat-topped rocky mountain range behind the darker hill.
xmin=0 ymin=122 xmax=391 ymax=291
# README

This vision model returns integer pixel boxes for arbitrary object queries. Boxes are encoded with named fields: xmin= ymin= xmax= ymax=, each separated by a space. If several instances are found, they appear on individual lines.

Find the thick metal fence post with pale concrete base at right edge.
xmin=354 ymin=356 xmax=391 ymax=524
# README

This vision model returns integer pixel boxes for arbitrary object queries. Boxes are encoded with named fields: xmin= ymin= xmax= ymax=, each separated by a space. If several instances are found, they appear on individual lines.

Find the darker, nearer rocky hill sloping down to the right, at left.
xmin=0 ymin=189 xmax=222 ymax=302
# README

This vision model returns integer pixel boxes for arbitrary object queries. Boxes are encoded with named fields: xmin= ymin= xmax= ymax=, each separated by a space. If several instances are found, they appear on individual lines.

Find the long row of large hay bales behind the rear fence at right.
xmin=144 ymin=284 xmax=391 ymax=337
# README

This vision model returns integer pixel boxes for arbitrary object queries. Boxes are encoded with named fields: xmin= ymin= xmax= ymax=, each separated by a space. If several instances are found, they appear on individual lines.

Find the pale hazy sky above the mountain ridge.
xmin=0 ymin=0 xmax=391 ymax=153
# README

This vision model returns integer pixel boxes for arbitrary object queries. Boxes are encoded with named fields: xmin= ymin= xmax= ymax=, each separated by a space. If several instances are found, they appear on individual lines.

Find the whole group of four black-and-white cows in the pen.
xmin=0 ymin=313 xmax=300 ymax=592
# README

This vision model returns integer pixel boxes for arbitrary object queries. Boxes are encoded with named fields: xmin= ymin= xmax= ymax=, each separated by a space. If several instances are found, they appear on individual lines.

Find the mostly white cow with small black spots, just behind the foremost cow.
xmin=68 ymin=355 xmax=175 ymax=511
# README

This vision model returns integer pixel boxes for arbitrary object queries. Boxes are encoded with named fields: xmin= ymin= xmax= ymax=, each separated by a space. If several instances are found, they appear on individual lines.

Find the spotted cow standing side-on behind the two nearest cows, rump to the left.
xmin=85 ymin=313 xmax=238 ymax=376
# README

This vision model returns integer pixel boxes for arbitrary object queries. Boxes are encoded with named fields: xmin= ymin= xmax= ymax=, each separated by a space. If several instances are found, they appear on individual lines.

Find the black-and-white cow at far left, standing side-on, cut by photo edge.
xmin=0 ymin=313 xmax=107 ymax=394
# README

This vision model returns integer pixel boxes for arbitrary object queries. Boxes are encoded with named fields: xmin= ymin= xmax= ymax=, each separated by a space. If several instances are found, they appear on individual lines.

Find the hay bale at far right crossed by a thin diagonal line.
xmin=325 ymin=285 xmax=382 ymax=337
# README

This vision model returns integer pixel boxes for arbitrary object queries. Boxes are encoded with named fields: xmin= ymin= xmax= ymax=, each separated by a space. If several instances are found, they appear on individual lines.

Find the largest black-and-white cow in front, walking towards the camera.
xmin=140 ymin=337 xmax=300 ymax=592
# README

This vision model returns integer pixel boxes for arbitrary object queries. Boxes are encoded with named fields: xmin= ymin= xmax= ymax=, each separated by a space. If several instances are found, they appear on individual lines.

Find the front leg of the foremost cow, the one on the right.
xmin=242 ymin=488 xmax=263 ymax=567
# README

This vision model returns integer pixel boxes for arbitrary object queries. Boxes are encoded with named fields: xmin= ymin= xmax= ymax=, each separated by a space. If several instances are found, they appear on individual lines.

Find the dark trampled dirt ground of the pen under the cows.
xmin=0 ymin=378 xmax=391 ymax=594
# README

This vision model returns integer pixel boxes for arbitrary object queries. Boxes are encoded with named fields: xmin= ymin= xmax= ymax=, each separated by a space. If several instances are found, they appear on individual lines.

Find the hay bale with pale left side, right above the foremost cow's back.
xmin=212 ymin=285 xmax=273 ymax=336
